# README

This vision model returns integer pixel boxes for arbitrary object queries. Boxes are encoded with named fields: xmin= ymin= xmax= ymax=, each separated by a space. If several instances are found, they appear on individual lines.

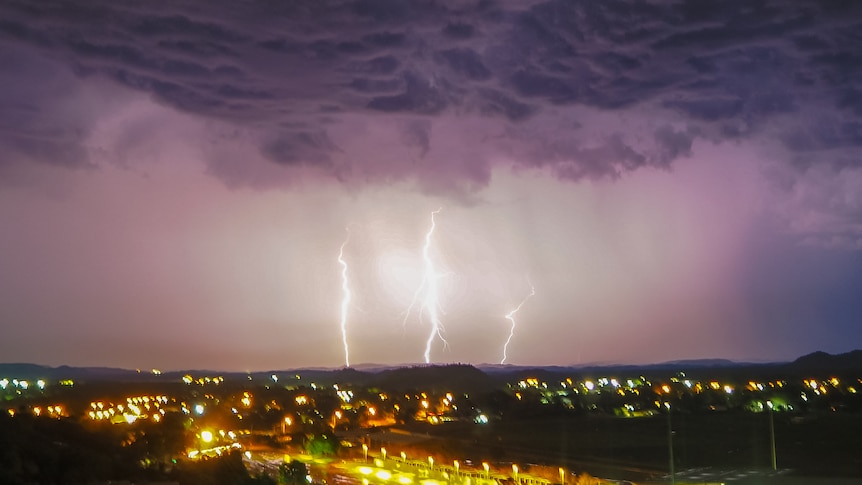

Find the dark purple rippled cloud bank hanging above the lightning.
xmin=0 ymin=0 xmax=862 ymax=247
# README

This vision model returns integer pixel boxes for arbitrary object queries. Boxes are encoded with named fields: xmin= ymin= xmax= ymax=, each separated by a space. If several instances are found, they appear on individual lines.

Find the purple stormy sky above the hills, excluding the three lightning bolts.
xmin=0 ymin=0 xmax=862 ymax=370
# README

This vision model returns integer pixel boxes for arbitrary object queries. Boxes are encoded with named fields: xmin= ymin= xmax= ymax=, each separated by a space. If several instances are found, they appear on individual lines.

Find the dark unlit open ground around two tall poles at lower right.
xmin=396 ymin=412 xmax=862 ymax=480
